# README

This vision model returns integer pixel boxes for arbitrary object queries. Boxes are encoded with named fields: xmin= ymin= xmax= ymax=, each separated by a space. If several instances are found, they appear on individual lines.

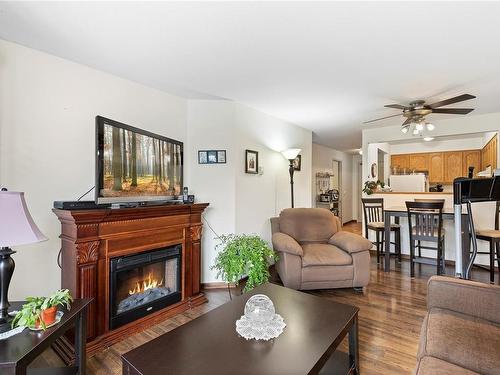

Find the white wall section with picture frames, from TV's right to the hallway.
xmin=187 ymin=100 xmax=312 ymax=282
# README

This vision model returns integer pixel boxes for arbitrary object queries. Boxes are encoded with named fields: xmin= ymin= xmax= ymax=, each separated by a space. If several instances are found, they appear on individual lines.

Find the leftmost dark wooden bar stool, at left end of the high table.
xmin=361 ymin=198 xmax=401 ymax=264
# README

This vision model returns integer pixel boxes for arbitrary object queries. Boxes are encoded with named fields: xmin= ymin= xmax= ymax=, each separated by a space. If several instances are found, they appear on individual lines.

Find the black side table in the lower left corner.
xmin=0 ymin=298 xmax=92 ymax=375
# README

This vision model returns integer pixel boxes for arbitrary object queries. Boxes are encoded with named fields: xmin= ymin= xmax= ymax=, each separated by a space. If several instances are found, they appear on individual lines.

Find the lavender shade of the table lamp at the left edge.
xmin=0 ymin=191 xmax=47 ymax=247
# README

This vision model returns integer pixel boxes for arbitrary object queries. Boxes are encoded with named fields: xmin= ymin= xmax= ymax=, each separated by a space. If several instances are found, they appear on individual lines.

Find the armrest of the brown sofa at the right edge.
xmin=427 ymin=276 xmax=500 ymax=323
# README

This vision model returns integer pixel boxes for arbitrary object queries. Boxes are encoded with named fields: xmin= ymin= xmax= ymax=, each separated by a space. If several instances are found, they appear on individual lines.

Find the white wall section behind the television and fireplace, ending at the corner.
xmin=0 ymin=40 xmax=186 ymax=299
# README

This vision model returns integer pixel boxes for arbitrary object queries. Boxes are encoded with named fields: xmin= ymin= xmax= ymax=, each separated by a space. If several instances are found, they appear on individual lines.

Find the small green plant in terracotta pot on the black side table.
xmin=12 ymin=289 xmax=73 ymax=330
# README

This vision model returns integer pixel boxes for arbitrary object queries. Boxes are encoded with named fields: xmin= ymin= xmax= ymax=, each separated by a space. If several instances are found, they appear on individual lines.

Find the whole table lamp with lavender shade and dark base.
xmin=0 ymin=189 xmax=47 ymax=325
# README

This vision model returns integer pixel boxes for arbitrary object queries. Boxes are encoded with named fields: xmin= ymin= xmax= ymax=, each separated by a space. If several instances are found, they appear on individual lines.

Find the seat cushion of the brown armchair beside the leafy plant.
xmin=302 ymin=243 xmax=352 ymax=267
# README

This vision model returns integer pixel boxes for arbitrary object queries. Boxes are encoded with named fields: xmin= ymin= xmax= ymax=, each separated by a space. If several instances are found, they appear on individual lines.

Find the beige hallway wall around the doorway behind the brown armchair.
xmin=312 ymin=143 xmax=357 ymax=223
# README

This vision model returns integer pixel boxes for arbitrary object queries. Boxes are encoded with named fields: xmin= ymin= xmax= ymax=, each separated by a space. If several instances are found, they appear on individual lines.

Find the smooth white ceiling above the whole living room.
xmin=0 ymin=1 xmax=500 ymax=150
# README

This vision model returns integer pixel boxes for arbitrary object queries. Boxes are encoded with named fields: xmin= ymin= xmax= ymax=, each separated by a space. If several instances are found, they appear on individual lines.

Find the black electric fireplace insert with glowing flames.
xmin=109 ymin=245 xmax=182 ymax=329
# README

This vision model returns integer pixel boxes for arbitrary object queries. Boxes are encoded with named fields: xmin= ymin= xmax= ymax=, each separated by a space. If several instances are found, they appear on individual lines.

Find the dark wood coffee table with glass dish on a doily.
xmin=122 ymin=284 xmax=359 ymax=375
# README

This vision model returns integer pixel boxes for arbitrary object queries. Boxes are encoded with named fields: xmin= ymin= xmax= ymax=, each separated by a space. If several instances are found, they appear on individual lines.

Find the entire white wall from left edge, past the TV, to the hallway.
xmin=0 ymin=40 xmax=312 ymax=299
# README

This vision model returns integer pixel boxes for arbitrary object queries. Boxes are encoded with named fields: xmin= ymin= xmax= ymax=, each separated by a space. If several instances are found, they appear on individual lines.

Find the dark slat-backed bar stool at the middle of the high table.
xmin=406 ymin=201 xmax=445 ymax=277
